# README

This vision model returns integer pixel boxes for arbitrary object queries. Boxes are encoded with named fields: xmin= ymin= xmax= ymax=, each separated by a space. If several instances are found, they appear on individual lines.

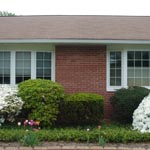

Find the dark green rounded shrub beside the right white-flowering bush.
xmin=110 ymin=87 xmax=149 ymax=123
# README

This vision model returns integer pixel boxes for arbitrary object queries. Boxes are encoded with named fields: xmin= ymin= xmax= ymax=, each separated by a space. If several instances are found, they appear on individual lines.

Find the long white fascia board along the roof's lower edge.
xmin=0 ymin=39 xmax=150 ymax=44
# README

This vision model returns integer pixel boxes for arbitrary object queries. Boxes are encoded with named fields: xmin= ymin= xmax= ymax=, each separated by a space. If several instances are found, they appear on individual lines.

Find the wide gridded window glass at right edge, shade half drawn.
xmin=127 ymin=51 xmax=150 ymax=86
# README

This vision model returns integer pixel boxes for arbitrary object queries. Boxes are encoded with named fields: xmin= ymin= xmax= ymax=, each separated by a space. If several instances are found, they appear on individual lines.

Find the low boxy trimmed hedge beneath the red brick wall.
xmin=58 ymin=93 xmax=104 ymax=125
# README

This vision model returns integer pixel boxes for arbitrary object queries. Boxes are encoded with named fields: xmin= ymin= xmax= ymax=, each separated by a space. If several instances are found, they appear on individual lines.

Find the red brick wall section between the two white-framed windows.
xmin=56 ymin=46 xmax=112 ymax=118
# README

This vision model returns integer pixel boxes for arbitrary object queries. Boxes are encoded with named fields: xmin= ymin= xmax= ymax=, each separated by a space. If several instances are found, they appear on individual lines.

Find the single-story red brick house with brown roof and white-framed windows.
xmin=0 ymin=16 xmax=150 ymax=117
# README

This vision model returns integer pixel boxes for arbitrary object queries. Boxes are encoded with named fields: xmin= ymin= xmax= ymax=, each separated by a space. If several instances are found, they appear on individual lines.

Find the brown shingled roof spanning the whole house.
xmin=0 ymin=15 xmax=150 ymax=40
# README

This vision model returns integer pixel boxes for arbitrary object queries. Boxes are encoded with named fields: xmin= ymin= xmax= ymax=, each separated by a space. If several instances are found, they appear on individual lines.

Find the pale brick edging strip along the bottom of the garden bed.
xmin=0 ymin=146 xmax=147 ymax=150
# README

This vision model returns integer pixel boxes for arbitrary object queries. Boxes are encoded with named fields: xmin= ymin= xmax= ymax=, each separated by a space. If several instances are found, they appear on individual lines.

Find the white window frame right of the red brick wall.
xmin=106 ymin=48 xmax=150 ymax=92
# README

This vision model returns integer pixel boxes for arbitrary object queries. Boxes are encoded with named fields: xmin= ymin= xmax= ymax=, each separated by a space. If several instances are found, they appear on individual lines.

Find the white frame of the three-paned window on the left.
xmin=1 ymin=50 xmax=55 ymax=86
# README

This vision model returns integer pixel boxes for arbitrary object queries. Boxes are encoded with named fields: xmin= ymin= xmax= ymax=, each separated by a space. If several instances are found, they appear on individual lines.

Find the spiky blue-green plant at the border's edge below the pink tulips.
xmin=20 ymin=130 xmax=41 ymax=148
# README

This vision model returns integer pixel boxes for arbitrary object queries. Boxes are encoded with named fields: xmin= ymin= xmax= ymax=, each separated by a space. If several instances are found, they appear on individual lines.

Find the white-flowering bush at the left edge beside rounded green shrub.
xmin=0 ymin=85 xmax=23 ymax=126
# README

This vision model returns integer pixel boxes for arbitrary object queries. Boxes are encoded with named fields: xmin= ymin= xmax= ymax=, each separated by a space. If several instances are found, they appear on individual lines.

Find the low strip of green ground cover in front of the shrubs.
xmin=0 ymin=124 xmax=150 ymax=143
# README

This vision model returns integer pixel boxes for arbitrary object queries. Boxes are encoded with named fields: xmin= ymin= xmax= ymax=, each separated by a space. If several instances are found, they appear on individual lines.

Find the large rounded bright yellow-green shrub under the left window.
xmin=18 ymin=79 xmax=64 ymax=126
